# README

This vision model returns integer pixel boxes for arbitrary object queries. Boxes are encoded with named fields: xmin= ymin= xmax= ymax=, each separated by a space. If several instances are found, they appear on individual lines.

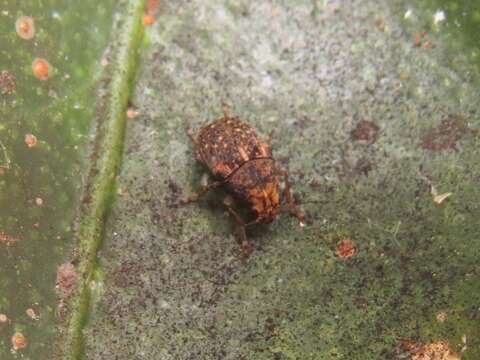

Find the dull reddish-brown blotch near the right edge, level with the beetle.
xmin=421 ymin=116 xmax=471 ymax=152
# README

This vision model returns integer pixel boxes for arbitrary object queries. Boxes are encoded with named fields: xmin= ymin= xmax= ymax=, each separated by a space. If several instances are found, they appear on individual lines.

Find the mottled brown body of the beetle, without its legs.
xmin=196 ymin=116 xmax=280 ymax=223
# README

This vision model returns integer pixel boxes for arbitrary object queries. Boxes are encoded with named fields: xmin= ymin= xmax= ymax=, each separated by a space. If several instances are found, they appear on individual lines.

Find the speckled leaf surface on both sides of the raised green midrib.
xmin=0 ymin=0 xmax=480 ymax=360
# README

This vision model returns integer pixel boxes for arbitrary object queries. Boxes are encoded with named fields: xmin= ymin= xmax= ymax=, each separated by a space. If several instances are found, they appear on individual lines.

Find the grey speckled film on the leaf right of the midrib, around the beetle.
xmin=86 ymin=0 xmax=480 ymax=360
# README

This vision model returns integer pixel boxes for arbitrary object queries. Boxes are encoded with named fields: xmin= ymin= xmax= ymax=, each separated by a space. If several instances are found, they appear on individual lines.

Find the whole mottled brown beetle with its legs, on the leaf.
xmin=182 ymin=109 xmax=305 ymax=254
